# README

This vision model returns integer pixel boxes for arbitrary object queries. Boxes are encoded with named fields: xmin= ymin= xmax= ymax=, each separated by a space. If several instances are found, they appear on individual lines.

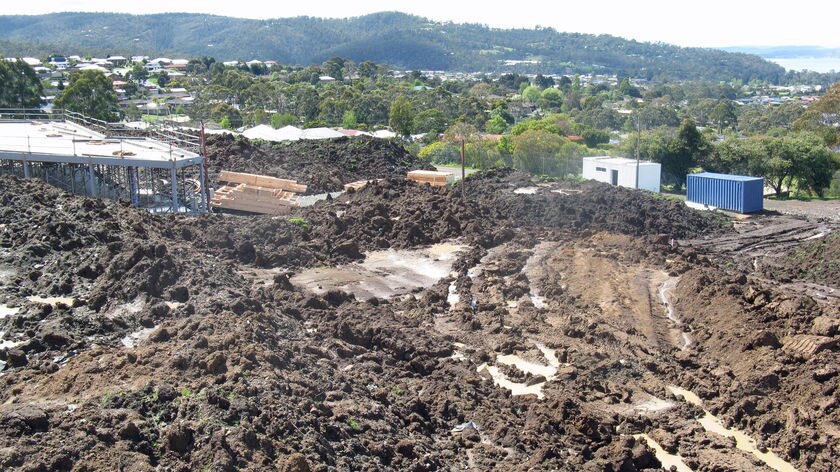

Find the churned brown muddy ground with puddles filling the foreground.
xmin=0 ymin=169 xmax=840 ymax=471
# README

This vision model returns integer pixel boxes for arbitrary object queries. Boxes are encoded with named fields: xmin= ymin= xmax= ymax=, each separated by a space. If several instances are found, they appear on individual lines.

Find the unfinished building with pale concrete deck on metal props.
xmin=0 ymin=109 xmax=208 ymax=213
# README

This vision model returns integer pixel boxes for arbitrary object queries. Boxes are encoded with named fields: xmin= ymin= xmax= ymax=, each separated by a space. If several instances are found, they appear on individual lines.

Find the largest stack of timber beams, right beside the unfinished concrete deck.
xmin=210 ymin=170 xmax=306 ymax=215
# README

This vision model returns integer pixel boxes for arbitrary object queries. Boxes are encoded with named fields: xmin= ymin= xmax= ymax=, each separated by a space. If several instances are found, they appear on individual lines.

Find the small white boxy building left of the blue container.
xmin=583 ymin=156 xmax=662 ymax=192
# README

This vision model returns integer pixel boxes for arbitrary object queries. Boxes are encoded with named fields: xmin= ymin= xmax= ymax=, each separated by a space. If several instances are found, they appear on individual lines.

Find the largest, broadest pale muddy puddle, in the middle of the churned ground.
xmin=291 ymin=242 xmax=468 ymax=300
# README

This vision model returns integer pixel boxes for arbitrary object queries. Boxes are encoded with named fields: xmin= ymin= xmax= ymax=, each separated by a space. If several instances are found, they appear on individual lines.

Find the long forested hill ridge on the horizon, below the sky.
xmin=0 ymin=12 xmax=784 ymax=82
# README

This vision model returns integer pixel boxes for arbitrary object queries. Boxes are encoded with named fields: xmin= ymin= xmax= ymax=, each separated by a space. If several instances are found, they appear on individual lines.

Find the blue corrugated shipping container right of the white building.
xmin=686 ymin=172 xmax=764 ymax=213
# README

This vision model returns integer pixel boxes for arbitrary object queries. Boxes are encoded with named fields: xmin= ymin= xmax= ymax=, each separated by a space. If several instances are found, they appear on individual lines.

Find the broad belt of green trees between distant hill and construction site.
xmin=0 ymin=51 xmax=840 ymax=196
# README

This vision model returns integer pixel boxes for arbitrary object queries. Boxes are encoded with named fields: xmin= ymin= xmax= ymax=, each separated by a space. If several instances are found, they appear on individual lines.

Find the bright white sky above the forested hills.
xmin=0 ymin=0 xmax=840 ymax=47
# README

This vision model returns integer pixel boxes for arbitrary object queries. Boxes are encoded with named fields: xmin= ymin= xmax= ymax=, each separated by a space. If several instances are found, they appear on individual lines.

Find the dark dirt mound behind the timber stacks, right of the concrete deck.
xmin=207 ymin=134 xmax=433 ymax=194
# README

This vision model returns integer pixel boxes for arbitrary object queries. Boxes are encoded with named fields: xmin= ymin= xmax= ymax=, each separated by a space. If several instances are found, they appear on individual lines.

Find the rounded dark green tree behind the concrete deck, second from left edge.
xmin=55 ymin=70 xmax=120 ymax=121
